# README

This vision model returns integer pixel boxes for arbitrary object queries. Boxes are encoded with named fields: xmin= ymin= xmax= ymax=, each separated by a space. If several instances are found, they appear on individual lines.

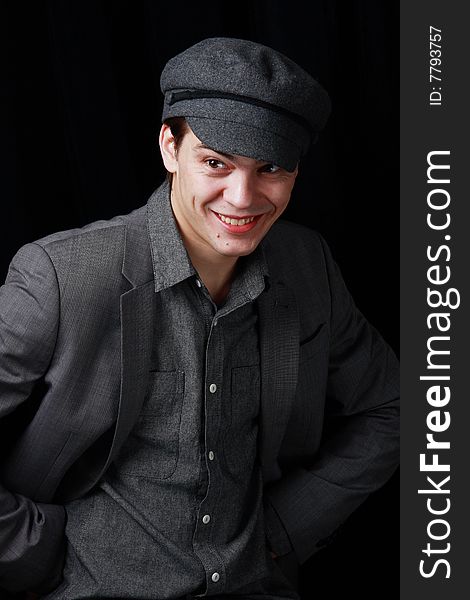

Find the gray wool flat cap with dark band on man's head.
xmin=160 ymin=38 xmax=330 ymax=171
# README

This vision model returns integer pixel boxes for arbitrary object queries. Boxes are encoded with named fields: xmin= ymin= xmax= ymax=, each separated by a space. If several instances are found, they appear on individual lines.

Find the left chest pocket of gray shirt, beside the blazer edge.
xmin=116 ymin=371 xmax=184 ymax=479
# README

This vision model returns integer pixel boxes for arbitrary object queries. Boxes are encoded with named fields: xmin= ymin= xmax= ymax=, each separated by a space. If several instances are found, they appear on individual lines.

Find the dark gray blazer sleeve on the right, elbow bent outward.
xmin=265 ymin=233 xmax=399 ymax=564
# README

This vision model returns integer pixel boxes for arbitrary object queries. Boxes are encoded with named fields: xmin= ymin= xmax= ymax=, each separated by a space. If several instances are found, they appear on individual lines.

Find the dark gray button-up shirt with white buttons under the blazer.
xmin=51 ymin=185 xmax=294 ymax=600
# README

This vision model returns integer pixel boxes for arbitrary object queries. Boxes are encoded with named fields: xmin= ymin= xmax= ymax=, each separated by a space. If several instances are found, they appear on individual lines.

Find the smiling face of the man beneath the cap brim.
xmin=160 ymin=125 xmax=297 ymax=260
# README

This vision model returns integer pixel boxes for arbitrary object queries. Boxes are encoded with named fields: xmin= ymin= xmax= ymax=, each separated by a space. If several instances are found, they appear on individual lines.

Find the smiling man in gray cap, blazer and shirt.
xmin=0 ymin=38 xmax=398 ymax=600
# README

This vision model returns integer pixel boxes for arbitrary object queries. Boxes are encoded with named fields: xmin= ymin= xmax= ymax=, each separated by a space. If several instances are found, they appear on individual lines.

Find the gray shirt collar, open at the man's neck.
xmin=147 ymin=181 xmax=269 ymax=300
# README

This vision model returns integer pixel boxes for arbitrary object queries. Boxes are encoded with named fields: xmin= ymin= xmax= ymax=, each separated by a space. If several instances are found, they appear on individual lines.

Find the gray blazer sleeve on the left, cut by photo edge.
xmin=0 ymin=244 xmax=65 ymax=592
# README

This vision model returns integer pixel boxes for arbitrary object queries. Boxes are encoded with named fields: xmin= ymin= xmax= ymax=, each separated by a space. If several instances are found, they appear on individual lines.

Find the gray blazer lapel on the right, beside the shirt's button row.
xmin=258 ymin=281 xmax=299 ymax=482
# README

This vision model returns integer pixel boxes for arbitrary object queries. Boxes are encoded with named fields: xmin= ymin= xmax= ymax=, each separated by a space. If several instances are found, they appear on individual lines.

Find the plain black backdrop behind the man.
xmin=0 ymin=0 xmax=399 ymax=600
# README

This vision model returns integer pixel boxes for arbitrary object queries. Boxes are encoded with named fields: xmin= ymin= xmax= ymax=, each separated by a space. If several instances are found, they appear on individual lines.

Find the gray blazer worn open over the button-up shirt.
xmin=0 ymin=185 xmax=399 ymax=590
